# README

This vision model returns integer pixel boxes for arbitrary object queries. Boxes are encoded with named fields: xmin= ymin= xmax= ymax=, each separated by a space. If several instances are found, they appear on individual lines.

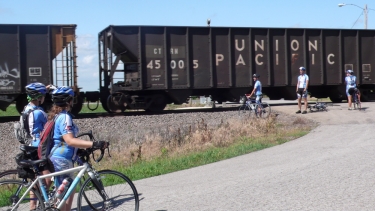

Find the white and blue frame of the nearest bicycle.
xmin=11 ymin=163 xmax=104 ymax=211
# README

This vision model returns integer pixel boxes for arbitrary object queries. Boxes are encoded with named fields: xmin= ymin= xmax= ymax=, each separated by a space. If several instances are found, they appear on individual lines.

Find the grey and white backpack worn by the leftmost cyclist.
xmin=14 ymin=108 xmax=34 ymax=145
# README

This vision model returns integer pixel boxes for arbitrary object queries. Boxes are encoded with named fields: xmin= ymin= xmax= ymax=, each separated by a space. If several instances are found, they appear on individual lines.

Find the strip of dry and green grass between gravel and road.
xmin=95 ymin=114 xmax=312 ymax=180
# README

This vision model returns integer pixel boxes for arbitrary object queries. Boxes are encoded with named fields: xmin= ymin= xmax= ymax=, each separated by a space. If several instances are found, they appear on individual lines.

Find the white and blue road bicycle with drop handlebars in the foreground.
xmin=0 ymin=132 xmax=139 ymax=211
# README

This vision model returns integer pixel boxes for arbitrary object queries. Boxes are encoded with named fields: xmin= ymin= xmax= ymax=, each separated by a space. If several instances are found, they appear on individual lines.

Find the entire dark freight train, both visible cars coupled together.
xmin=0 ymin=25 xmax=375 ymax=113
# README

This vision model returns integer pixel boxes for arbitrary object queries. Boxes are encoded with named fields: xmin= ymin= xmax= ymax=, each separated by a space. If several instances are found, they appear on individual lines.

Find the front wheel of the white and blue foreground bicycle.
xmin=77 ymin=170 xmax=139 ymax=211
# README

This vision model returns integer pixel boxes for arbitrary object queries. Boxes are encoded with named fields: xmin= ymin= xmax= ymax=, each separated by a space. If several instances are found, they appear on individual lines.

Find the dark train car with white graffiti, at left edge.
xmin=0 ymin=24 xmax=82 ymax=113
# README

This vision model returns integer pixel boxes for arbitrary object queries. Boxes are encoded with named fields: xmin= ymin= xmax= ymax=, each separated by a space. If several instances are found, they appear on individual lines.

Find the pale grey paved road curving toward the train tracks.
xmin=135 ymin=103 xmax=375 ymax=210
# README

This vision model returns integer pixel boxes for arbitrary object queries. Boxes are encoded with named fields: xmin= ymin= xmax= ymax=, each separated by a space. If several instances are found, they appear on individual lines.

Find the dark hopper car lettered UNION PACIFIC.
xmin=99 ymin=26 xmax=375 ymax=111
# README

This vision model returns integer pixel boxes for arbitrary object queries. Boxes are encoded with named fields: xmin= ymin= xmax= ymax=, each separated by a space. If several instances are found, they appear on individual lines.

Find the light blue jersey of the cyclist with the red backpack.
xmin=51 ymin=111 xmax=79 ymax=160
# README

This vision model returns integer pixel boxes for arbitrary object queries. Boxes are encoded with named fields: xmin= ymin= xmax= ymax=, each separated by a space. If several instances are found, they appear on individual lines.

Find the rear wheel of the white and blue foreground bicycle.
xmin=0 ymin=180 xmax=44 ymax=211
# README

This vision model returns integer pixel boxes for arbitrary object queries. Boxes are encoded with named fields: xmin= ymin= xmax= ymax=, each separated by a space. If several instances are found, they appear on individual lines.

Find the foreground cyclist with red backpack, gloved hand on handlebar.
xmin=48 ymin=86 xmax=108 ymax=210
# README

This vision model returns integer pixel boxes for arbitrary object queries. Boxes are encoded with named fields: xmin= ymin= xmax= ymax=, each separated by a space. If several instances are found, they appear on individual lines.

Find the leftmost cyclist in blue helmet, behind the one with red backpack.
xmin=23 ymin=83 xmax=51 ymax=210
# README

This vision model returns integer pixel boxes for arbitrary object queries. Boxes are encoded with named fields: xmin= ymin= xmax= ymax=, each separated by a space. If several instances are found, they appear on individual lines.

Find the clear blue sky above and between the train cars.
xmin=0 ymin=0 xmax=375 ymax=91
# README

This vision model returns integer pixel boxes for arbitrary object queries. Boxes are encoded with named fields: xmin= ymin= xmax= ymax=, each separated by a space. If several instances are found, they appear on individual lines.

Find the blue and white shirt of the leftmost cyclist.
xmin=24 ymin=103 xmax=47 ymax=146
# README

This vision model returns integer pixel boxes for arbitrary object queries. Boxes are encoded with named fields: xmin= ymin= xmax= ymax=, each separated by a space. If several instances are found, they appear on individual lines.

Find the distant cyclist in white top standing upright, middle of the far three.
xmin=296 ymin=67 xmax=309 ymax=114
